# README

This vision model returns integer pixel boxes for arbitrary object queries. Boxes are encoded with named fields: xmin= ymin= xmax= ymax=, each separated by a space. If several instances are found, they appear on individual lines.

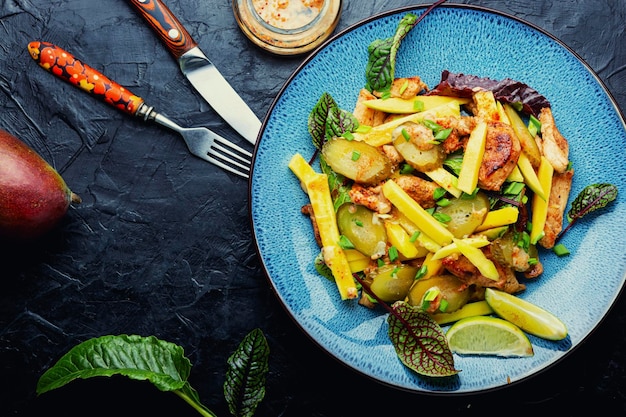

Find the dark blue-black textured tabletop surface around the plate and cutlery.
xmin=0 ymin=0 xmax=626 ymax=417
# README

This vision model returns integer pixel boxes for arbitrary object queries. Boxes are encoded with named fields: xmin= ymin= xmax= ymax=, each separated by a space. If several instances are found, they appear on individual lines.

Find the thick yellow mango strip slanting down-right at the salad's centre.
xmin=382 ymin=180 xmax=454 ymax=246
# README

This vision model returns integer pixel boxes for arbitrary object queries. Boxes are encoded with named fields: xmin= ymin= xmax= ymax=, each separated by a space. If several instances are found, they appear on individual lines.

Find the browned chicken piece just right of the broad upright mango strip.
xmin=478 ymin=122 xmax=522 ymax=191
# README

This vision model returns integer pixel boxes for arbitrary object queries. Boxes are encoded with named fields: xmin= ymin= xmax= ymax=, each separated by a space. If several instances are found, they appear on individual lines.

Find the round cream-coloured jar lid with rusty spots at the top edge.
xmin=233 ymin=0 xmax=342 ymax=55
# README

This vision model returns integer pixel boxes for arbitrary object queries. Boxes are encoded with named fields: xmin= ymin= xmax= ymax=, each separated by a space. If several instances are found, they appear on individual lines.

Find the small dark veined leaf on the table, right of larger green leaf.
xmin=224 ymin=329 xmax=270 ymax=417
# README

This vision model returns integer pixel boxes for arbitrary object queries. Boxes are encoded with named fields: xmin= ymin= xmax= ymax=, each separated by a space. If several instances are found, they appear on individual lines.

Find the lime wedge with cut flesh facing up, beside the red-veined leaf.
xmin=446 ymin=316 xmax=533 ymax=357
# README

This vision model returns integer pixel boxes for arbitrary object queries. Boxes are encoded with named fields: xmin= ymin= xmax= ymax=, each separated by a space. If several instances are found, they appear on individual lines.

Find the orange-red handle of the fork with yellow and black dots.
xmin=28 ymin=41 xmax=143 ymax=115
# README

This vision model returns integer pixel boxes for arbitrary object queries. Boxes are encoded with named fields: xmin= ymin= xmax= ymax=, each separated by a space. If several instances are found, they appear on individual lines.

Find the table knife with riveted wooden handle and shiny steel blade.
xmin=130 ymin=0 xmax=261 ymax=144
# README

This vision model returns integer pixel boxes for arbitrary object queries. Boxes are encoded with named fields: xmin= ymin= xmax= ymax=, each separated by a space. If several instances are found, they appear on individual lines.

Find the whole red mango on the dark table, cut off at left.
xmin=0 ymin=129 xmax=81 ymax=240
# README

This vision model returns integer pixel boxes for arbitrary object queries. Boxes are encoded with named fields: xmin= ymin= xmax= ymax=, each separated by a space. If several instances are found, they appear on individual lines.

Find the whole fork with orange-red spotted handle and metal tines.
xmin=28 ymin=41 xmax=252 ymax=178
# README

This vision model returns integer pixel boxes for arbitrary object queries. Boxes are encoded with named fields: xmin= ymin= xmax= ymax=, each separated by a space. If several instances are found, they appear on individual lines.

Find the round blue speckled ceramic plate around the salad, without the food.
xmin=249 ymin=6 xmax=626 ymax=393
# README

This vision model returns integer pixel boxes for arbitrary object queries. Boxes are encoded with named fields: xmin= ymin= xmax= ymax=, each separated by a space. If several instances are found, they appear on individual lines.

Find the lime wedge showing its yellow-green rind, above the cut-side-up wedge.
xmin=485 ymin=288 xmax=567 ymax=340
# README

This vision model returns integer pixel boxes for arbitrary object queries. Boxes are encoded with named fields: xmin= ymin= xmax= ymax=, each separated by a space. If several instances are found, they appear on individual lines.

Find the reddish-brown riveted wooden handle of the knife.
xmin=130 ymin=0 xmax=198 ymax=59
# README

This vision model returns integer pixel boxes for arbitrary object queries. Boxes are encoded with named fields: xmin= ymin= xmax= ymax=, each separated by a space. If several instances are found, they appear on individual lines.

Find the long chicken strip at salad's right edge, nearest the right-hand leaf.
xmin=539 ymin=169 xmax=574 ymax=249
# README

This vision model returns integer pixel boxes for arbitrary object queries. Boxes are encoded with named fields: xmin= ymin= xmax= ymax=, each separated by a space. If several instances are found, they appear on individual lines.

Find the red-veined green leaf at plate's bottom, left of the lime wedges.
xmin=387 ymin=301 xmax=459 ymax=377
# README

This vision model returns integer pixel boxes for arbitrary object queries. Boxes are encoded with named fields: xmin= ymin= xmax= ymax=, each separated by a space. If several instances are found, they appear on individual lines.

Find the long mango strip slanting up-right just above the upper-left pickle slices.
xmin=353 ymin=101 xmax=461 ymax=147
